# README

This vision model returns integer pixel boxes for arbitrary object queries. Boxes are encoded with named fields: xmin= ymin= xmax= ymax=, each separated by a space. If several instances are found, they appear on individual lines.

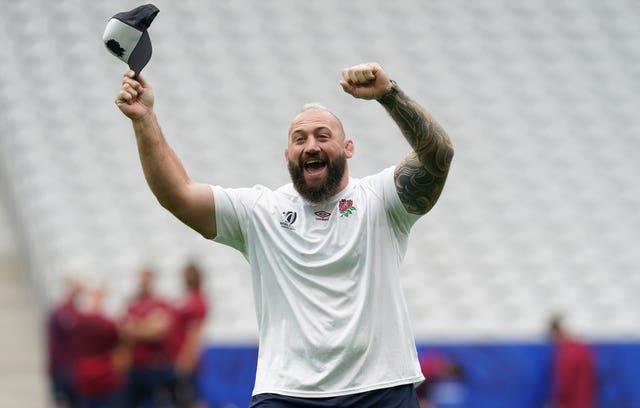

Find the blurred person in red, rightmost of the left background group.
xmin=166 ymin=263 xmax=208 ymax=408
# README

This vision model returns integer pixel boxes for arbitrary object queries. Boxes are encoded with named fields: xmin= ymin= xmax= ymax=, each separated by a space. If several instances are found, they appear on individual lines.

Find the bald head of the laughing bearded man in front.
xmin=284 ymin=104 xmax=354 ymax=202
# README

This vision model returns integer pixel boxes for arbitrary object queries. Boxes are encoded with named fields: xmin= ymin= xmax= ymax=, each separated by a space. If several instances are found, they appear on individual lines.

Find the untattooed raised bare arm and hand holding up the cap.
xmin=116 ymin=71 xmax=216 ymax=238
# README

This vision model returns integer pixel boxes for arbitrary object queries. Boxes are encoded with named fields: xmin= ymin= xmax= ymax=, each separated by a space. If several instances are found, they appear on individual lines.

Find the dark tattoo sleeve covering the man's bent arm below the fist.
xmin=378 ymin=81 xmax=453 ymax=214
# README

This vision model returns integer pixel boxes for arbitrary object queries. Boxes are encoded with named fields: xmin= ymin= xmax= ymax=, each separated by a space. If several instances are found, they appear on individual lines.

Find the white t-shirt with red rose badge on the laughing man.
xmin=212 ymin=167 xmax=424 ymax=397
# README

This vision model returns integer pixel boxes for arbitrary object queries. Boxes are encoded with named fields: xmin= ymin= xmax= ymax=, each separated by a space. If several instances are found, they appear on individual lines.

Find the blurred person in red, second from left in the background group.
xmin=70 ymin=287 xmax=123 ymax=408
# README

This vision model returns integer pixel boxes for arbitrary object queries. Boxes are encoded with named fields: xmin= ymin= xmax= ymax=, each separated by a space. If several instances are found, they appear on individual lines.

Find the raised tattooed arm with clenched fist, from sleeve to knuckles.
xmin=340 ymin=63 xmax=453 ymax=214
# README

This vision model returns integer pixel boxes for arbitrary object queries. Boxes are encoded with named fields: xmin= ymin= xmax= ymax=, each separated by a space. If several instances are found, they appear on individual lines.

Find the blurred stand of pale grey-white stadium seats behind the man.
xmin=0 ymin=0 xmax=640 ymax=406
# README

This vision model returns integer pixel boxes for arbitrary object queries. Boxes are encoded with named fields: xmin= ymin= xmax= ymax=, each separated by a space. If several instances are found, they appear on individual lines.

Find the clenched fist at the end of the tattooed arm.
xmin=340 ymin=62 xmax=391 ymax=99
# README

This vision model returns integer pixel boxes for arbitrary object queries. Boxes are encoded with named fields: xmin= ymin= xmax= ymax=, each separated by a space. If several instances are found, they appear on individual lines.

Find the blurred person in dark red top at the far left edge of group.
xmin=46 ymin=277 xmax=82 ymax=408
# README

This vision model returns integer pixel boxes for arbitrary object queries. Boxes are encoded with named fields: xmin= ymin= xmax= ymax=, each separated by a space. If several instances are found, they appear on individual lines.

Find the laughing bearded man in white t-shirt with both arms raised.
xmin=116 ymin=63 xmax=453 ymax=408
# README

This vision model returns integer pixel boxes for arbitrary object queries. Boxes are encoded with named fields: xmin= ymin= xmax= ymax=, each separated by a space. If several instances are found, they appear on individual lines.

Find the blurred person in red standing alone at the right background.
xmin=549 ymin=316 xmax=597 ymax=408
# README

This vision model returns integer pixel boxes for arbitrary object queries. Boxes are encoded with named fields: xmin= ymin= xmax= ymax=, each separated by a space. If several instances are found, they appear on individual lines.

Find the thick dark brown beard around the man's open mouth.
xmin=287 ymin=152 xmax=347 ymax=203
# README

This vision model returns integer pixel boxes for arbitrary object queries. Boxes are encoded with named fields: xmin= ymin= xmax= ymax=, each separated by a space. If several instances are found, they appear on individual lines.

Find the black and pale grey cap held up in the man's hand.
xmin=102 ymin=4 xmax=160 ymax=75
